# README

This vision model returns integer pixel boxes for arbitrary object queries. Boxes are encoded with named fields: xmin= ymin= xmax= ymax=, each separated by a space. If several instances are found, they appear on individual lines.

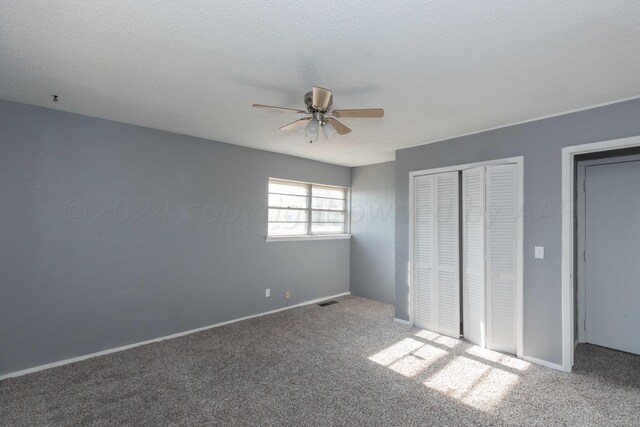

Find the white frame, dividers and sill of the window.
xmin=266 ymin=177 xmax=351 ymax=242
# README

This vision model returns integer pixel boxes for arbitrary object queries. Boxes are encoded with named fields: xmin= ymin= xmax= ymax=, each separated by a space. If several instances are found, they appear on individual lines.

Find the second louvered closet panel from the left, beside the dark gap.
xmin=434 ymin=171 xmax=460 ymax=338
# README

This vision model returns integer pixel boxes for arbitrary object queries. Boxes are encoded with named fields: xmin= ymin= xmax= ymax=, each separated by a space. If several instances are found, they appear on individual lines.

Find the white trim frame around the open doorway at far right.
xmin=561 ymin=136 xmax=640 ymax=372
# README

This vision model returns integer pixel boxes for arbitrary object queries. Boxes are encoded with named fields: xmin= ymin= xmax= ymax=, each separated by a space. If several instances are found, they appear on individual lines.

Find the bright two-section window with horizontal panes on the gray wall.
xmin=267 ymin=179 xmax=347 ymax=237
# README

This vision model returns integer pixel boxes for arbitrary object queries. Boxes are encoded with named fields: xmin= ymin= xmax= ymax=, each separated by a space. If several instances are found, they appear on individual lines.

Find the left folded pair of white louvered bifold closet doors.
xmin=413 ymin=172 xmax=460 ymax=338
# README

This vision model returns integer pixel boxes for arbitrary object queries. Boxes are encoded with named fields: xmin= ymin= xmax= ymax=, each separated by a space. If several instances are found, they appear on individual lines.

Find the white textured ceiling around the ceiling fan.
xmin=0 ymin=0 xmax=640 ymax=166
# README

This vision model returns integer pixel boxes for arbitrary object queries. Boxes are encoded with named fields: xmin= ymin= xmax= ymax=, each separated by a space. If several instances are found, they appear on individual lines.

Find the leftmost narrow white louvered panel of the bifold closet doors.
xmin=413 ymin=175 xmax=435 ymax=329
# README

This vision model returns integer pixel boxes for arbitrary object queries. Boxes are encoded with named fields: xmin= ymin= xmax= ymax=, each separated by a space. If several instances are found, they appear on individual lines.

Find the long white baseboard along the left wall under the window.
xmin=0 ymin=292 xmax=351 ymax=381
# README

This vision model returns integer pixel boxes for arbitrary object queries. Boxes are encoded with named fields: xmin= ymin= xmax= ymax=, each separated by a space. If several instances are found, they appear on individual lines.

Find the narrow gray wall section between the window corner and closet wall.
xmin=351 ymin=162 xmax=395 ymax=304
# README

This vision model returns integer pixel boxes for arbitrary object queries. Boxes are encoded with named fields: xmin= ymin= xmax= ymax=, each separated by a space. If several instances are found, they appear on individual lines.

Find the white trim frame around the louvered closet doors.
xmin=407 ymin=156 xmax=527 ymax=360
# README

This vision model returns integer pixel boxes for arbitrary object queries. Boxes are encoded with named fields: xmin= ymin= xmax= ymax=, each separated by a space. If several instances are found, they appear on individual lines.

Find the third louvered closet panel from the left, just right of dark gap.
xmin=462 ymin=166 xmax=487 ymax=347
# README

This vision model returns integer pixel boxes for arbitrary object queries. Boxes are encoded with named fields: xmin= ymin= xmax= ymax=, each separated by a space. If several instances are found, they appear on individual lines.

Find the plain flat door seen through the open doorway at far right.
xmin=584 ymin=161 xmax=640 ymax=354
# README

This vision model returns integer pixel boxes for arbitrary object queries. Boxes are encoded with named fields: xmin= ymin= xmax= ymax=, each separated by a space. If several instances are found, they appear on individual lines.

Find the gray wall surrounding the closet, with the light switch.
xmin=395 ymin=100 xmax=640 ymax=364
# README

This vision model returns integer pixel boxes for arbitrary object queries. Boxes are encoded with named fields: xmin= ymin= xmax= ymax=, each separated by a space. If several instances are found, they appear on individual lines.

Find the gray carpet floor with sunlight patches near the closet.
xmin=0 ymin=297 xmax=640 ymax=426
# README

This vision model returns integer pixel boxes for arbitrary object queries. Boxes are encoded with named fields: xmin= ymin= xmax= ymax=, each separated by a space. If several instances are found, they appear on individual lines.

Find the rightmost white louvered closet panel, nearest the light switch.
xmin=486 ymin=164 xmax=518 ymax=353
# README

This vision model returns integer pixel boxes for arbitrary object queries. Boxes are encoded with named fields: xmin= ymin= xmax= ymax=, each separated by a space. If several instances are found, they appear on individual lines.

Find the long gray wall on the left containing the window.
xmin=0 ymin=101 xmax=351 ymax=374
